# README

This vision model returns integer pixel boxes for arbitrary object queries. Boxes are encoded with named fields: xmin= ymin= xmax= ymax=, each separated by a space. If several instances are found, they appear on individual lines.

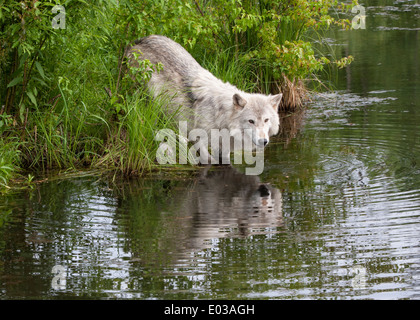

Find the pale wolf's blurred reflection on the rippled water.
xmin=169 ymin=166 xmax=283 ymax=251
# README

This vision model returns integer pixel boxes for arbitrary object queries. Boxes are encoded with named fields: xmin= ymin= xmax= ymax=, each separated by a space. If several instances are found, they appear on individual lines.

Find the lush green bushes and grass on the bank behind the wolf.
xmin=0 ymin=0 xmax=351 ymax=186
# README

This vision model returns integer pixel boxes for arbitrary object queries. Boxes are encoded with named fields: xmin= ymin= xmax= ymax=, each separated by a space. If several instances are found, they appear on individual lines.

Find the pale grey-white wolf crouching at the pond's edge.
xmin=126 ymin=35 xmax=282 ymax=163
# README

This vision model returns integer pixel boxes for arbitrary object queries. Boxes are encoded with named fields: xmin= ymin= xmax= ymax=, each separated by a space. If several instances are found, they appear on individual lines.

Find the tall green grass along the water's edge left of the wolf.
xmin=0 ymin=88 xmax=176 ymax=187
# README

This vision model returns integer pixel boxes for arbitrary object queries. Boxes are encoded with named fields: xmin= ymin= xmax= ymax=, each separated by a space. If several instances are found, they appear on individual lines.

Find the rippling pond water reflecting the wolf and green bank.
xmin=0 ymin=1 xmax=420 ymax=299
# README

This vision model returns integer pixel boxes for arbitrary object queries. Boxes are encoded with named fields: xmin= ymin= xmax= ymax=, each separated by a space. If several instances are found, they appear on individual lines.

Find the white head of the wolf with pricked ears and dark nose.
xmin=233 ymin=93 xmax=283 ymax=147
